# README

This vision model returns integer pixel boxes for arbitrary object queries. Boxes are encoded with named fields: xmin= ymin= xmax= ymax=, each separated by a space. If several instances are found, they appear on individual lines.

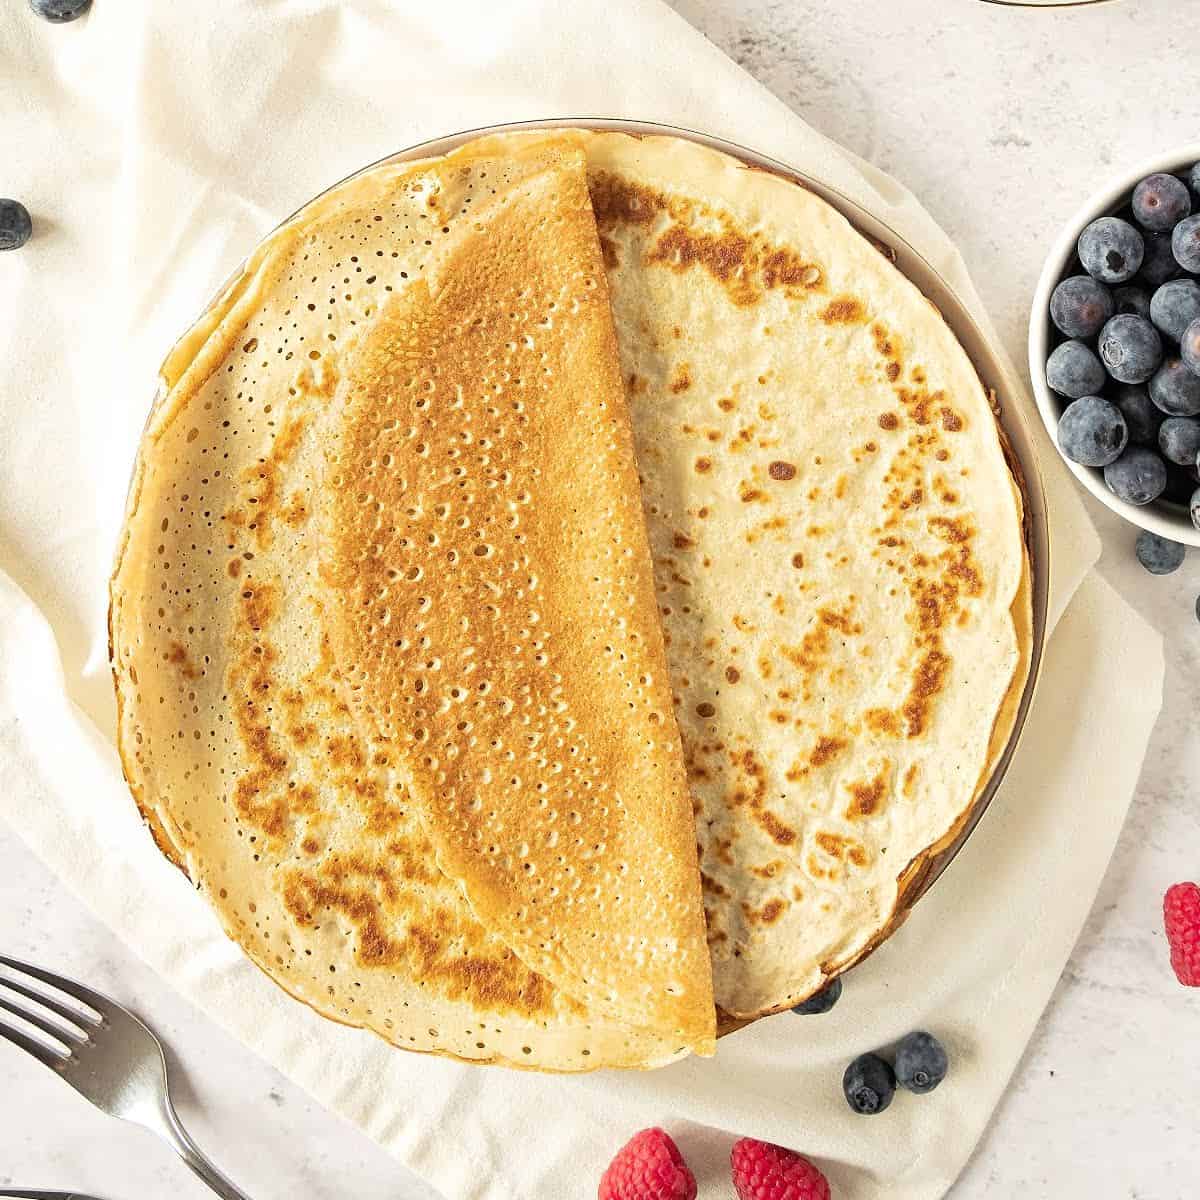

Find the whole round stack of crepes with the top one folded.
xmin=110 ymin=131 xmax=1031 ymax=1070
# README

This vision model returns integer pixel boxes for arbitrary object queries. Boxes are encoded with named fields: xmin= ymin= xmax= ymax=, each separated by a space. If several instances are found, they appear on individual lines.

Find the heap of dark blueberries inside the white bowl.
xmin=1045 ymin=163 xmax=1200 ymax=529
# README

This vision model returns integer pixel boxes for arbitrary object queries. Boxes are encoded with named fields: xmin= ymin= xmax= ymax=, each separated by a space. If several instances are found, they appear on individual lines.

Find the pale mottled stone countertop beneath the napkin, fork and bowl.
xmin=0 ymin=0 xmax=1200 ymax=1200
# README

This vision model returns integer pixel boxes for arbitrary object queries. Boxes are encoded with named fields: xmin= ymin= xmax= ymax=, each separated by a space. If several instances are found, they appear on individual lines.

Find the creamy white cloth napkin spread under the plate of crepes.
xmin=0 ymin=0 xmax=1162 ymax=1200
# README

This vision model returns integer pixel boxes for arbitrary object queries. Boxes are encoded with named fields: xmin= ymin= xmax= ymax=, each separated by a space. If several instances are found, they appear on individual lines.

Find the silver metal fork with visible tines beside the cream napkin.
xmin=0 ymin=954 xmax=248 ymax=1200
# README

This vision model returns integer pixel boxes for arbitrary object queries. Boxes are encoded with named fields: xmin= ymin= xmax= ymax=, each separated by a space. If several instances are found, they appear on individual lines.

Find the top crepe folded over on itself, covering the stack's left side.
xmin=112 ymin=140 xmax=714 ymax=1070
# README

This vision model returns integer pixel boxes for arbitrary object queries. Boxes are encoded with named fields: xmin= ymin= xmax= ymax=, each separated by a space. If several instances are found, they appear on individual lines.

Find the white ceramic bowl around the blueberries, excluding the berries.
xmin=1030 ymin=144 xmax=1200 ymax=546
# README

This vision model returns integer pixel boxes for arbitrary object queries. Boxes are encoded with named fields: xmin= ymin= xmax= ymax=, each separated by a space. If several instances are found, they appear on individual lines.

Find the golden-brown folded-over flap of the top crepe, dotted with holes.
xmin=319 ymin=152 xmax=714 ymax=1048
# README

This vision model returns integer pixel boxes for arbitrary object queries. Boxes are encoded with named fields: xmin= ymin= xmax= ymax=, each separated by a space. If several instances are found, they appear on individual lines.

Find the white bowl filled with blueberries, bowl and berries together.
xmin=1030 ymin=146 xmax=1200 ymax=546
